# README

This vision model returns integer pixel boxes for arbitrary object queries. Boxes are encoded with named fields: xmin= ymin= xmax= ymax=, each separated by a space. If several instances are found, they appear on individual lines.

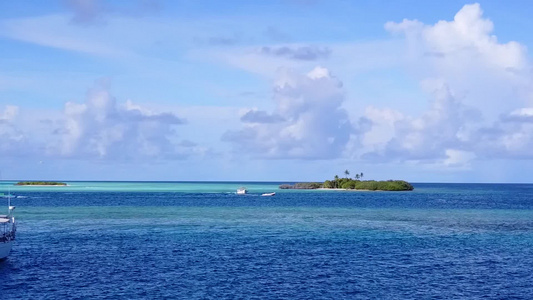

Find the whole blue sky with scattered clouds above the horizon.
xmin=0 ymin=0 xmax=533 ymax=183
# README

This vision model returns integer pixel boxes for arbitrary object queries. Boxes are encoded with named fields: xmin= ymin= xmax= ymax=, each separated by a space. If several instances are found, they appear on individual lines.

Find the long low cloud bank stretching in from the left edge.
xmin=0 ymin=81 xmax=211 ymax=162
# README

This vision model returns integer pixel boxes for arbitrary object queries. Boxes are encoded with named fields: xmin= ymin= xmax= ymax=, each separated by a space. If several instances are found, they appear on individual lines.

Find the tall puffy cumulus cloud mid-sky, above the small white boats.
xmin=223 ymin=67 xmax=354 ymax=159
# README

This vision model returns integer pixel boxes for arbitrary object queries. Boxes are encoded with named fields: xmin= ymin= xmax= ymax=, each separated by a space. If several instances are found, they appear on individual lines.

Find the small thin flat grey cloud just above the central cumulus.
xmin=259 ymin=46 xmax=331 ymax=61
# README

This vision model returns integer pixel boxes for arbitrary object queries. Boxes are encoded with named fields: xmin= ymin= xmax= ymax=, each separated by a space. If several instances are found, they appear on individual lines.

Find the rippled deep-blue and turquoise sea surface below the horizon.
xmin=0 ymin=181 xmax=533 ymax=299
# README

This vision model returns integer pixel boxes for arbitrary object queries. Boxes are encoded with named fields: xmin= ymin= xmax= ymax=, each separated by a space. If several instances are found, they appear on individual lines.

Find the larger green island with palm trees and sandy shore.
xmin=279 ymin=170 xmax=414 ymax=191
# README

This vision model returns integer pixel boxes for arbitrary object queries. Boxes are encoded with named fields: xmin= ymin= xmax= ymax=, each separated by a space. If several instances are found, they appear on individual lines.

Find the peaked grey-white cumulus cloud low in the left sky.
xmin=48 ymin=79 xmax=203 ymax=160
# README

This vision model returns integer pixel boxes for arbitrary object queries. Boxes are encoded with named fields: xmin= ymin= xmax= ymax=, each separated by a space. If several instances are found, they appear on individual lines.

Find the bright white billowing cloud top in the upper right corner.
xmin=385 ymin=4 xmax=533 ymax=124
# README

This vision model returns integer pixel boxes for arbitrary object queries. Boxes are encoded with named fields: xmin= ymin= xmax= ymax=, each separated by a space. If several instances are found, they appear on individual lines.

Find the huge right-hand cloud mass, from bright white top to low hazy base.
xmin=363 ymin=4 xmax=533 ymax=169
